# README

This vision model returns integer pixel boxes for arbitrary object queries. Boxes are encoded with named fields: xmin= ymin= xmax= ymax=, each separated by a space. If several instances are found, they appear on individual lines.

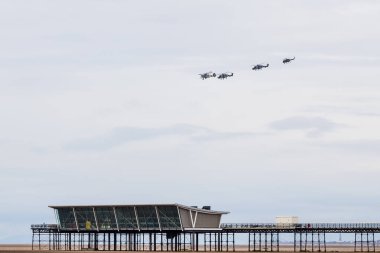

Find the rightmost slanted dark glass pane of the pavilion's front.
xmin=157 ymin=206 xmax=181 ymax=230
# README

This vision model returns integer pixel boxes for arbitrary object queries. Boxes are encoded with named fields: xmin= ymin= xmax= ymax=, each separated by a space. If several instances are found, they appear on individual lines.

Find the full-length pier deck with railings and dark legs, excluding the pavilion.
xmin=32 ymin=223 xmax=380 ymax=252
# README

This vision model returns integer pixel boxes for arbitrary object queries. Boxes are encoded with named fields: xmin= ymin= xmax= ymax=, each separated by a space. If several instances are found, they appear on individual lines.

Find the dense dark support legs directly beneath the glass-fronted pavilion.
xmin=32 ymin=228 xmax=235 ymax=251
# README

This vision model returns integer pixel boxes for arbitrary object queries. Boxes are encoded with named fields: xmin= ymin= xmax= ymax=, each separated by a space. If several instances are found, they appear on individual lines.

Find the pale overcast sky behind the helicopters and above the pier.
xmin=0 ymin=0 xmax=380 ymax=243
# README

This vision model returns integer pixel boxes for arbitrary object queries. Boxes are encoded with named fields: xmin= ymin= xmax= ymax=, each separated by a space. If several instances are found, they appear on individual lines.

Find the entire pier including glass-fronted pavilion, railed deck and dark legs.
xmin=31 ymin=204 xmax=380 ymax=251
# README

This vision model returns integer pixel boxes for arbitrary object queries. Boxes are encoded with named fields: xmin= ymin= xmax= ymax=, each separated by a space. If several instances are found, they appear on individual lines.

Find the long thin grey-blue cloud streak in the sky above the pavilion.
xmin=64 ymin=124 xmax=256 ymax=150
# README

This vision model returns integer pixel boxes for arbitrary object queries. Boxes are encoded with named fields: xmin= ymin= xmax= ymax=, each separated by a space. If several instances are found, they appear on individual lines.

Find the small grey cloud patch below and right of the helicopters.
xmin=270 ymin=117 xmax=340 ymax=137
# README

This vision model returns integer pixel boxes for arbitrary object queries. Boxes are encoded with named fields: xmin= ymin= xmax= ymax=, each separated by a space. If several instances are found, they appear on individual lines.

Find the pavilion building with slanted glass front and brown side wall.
xmin=52 ymin=204 xmax=226 ymax=231
